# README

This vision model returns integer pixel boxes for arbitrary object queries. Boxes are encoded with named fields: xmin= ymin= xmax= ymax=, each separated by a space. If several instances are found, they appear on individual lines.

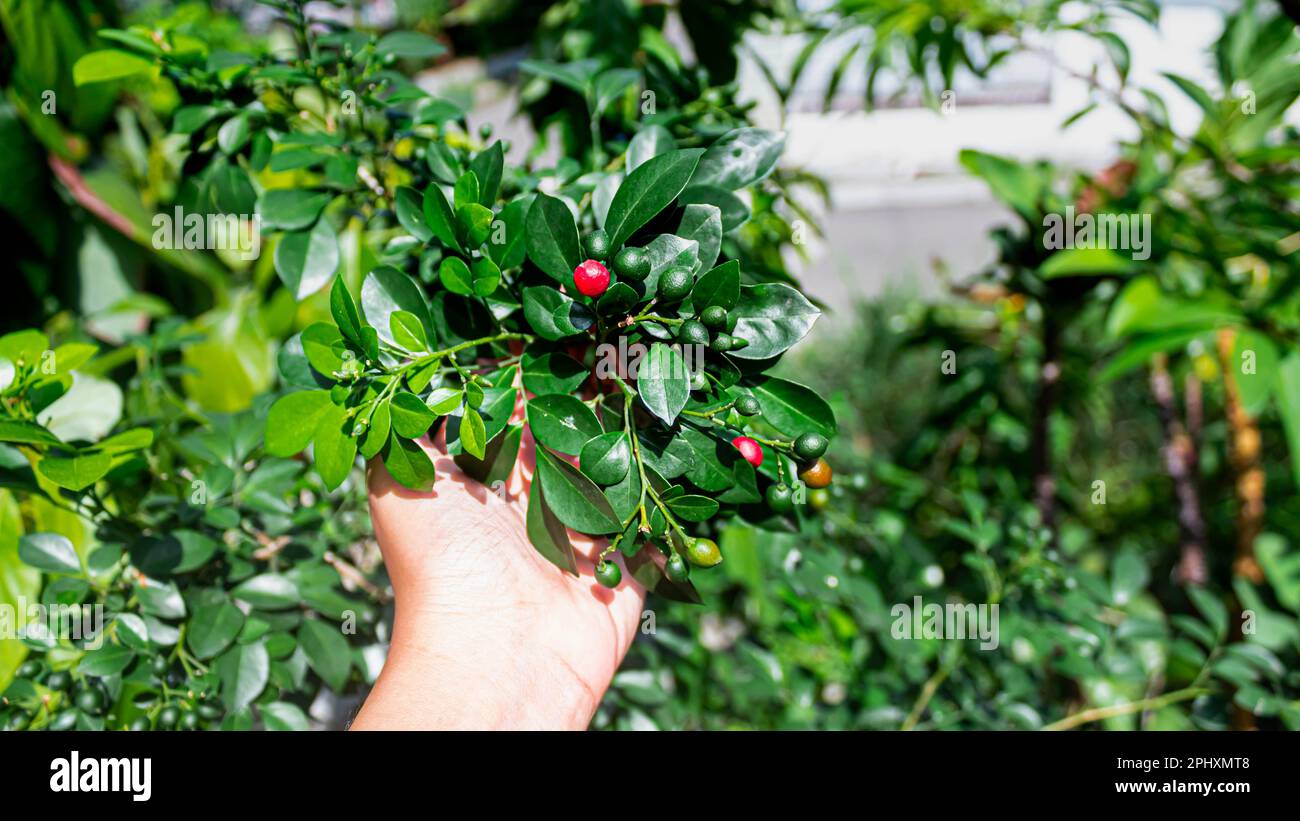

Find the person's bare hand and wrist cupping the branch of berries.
xmin=352 ymin=405 xmax=645 ymax=730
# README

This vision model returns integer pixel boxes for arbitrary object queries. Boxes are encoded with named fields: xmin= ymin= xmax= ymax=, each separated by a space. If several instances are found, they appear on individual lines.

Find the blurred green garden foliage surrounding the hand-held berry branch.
xmin=0 ymin=0 xmax=1300 ymax=729
